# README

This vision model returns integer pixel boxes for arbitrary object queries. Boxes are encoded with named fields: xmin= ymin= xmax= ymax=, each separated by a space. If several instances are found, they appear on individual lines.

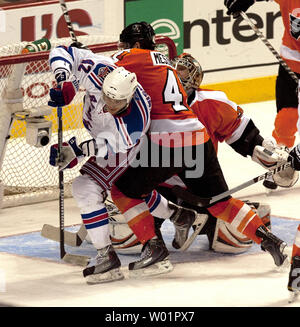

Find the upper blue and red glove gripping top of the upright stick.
xmin=48 ymin=81 xmax=79 ymax=107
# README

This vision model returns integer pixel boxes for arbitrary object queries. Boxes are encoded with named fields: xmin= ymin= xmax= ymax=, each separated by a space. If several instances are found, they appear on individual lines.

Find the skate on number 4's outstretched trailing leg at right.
xmin=256 ymin=226 xmax=288 ymax=266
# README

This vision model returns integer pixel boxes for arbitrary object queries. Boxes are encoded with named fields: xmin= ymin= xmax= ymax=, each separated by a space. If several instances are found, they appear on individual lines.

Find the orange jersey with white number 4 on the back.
xmin=113 ymin=48 xmax=209 ymax=146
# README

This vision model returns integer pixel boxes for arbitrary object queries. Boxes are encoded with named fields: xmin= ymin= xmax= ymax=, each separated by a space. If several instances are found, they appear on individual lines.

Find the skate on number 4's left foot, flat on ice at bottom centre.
xmin=128 ymin=238 xmax=173 ymax=278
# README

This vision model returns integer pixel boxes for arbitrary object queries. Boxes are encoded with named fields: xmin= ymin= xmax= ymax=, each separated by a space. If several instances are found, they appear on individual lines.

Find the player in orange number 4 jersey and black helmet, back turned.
xmin=111 ymin=22 xmax=286 ymax=276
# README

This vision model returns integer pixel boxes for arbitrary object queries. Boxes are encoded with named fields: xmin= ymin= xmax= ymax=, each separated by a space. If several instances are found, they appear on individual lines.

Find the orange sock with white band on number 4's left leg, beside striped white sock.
xmin=110 ymin=185 xmax=156 ymax=244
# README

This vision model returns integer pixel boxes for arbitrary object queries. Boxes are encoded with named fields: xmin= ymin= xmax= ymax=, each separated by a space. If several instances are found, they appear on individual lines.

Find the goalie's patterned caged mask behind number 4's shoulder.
xmin=172 ymin=53 xmax=203 ymax=91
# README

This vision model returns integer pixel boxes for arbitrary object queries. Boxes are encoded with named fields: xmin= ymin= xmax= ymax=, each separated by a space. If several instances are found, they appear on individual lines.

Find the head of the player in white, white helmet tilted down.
xmin=102 ymin=67 xmax=138 ymax=114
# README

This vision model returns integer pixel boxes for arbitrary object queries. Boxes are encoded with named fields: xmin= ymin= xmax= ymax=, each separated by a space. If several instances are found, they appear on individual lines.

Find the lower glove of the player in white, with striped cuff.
xmin=49 ymin=136 xmax=97 ymax=170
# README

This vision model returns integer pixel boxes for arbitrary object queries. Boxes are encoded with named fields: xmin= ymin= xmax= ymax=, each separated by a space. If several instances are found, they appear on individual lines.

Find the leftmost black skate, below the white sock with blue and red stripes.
xmin=83 ymin=245 xmax=124 ymax=284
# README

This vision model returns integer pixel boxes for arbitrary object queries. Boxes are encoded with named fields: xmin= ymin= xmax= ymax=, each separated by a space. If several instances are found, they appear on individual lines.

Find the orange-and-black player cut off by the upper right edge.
xmin=224 ymin=0 xmax=300 ymax=185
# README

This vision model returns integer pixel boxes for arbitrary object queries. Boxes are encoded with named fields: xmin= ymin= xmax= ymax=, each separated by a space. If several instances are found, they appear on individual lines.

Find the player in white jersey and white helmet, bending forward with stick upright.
xmin=49 ymin=47 xmax=197 ymax=283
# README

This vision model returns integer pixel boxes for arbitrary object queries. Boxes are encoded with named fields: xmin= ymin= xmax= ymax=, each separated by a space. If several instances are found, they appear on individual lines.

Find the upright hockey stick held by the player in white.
xmin=57 ymin=107 xmax=90 ymax=266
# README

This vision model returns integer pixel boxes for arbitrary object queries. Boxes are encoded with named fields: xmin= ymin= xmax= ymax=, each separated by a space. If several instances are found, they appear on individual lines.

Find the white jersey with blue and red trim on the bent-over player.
xmin=49 ymin=46 xmax=151 ymax=157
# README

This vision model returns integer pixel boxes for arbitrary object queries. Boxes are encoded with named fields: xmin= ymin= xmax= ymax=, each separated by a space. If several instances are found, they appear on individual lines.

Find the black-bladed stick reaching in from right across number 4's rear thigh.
xmin=172 ymin=162 xmax=291 ymax=207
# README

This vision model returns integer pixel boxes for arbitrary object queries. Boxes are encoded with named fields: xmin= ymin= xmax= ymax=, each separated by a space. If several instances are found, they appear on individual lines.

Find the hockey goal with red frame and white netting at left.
xmin=0 ymin=35 xmax=176 ymax=208
